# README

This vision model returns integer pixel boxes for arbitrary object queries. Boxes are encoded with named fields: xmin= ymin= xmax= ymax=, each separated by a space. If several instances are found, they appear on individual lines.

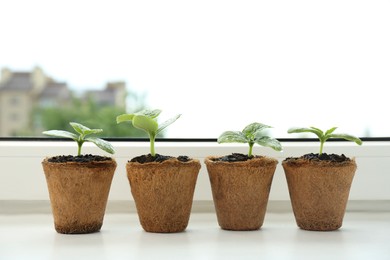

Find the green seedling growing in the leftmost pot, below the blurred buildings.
xmin=42 ymin=122 xmax=115 ymax=156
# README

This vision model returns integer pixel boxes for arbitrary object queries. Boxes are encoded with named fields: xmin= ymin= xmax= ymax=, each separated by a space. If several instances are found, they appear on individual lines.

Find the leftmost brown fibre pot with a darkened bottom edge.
xmin=42 ymin=158 xmax=116 ymax=234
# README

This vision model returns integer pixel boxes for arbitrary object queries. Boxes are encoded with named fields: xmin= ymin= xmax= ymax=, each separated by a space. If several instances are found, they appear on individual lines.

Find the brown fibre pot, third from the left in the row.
xmin=205 ymin=156 xmax=278 ymax=231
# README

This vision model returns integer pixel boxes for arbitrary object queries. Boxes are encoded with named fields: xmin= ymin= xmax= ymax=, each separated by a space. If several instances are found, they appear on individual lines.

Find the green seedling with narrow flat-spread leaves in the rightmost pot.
xmin=287 ymin=126 xmax=362 ymax=155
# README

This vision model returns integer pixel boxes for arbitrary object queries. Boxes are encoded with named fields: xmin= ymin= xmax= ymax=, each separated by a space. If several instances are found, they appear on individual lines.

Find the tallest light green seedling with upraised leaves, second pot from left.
xmin=116 ymin=109 xmax=181 ymax=157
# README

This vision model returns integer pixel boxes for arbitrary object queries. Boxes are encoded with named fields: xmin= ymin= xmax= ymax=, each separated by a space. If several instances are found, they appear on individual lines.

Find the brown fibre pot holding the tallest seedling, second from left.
xmin=126 ymin=158 xmax=200 ymax=233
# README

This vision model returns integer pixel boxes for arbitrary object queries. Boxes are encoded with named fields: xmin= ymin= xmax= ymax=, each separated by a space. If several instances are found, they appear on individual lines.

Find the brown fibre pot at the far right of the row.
xmin=282 ymin=159 xmax=357 ymax=231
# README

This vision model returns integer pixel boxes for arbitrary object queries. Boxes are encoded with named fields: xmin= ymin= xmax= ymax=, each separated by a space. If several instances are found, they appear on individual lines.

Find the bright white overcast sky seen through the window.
xmin=0 ymin=0 xmax=390 ymax=138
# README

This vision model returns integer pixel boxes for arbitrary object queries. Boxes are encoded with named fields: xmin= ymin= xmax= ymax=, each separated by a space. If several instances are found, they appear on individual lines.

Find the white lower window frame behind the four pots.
xmin=0 ymin=141 xmax=390 ymax=201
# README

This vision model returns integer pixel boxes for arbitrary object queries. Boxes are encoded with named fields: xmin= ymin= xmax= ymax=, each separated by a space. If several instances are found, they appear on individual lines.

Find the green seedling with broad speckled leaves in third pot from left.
xmin=218 ymin=123 xmax=282 ymax=157
